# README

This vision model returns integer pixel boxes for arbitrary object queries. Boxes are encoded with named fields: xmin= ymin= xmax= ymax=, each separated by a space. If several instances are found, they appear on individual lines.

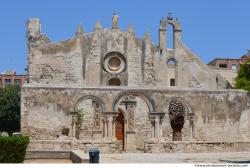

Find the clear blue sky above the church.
xmin=0 ymin=0 xmax=250 ymax=73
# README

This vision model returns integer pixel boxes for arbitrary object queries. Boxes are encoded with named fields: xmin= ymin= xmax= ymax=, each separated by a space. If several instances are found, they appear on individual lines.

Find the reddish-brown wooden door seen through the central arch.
xmin=115 ymin=110 xmax=124 ymax=150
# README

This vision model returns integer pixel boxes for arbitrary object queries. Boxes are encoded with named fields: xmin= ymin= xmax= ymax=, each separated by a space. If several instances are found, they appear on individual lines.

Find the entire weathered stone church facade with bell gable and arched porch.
xmin=21 ymin=14 xmax=250 ymax=153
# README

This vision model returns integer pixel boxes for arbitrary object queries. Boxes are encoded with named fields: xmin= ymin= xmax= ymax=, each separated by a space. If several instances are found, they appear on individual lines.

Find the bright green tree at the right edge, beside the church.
xmin=235 ymin=58 xmax=250 ymax=92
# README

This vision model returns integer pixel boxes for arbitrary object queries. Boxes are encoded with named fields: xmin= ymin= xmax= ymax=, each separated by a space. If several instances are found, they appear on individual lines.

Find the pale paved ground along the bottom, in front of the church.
xmin=24 ymin=152 xmax=250 ymax=163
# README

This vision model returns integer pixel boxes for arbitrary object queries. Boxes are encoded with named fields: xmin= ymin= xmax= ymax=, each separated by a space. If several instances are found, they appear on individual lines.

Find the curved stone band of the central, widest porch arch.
xmin=112 ymin=91 xmax=155 ymax=112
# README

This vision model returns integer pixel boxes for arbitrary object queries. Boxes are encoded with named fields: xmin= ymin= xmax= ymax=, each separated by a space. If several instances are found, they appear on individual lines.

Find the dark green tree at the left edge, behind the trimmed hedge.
xmin=0 ymin=85 xmax=20 ymax=134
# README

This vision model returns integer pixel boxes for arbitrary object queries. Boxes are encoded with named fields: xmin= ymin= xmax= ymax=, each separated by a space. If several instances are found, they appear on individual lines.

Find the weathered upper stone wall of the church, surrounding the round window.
xmin=27 ymin=20 xmax=228 ymax=89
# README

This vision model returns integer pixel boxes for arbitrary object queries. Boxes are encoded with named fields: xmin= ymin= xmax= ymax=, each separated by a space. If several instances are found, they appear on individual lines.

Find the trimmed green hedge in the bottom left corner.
xmin=0 ymin=136 xmax=29 ymax=163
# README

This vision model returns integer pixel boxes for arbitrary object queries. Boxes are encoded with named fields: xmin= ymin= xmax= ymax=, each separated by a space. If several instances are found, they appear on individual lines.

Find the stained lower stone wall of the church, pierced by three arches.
xmin=21 ymin=86 xmax=249 ymax=145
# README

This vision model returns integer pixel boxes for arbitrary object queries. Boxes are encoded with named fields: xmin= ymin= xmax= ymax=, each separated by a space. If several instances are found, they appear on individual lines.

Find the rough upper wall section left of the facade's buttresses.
xmin=29 ymin=39 xmax=83 ymax=85
